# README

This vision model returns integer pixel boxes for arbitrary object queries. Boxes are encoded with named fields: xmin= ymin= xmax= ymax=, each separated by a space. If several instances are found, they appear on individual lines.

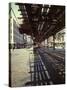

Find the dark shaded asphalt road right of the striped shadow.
xmin=37 ymin=48 xmax=65 ymax=84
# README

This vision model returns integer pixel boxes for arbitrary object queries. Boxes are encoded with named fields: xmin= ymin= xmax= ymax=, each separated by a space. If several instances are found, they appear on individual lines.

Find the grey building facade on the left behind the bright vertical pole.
xmin=10 ymin=18 xmax=24 ymax=49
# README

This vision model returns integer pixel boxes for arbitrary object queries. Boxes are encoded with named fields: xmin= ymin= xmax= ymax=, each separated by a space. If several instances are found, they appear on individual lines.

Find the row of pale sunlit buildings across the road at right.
xmin=41 ymin=30 xmax=65 ymax=48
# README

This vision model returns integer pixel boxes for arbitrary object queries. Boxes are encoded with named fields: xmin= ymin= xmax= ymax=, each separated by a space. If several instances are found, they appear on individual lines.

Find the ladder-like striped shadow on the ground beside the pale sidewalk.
xmin=25 ymin=49 xmax=53 ymax=86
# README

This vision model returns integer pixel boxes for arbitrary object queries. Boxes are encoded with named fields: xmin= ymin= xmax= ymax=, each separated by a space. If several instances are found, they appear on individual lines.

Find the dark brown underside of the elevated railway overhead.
xmin=16 ymin=3 xmax=65 ymax=42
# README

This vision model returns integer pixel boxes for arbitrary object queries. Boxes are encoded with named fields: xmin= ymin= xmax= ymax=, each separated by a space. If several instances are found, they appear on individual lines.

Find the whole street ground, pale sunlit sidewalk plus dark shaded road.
xmin=11 ymin=48 xmax=65 ymax=87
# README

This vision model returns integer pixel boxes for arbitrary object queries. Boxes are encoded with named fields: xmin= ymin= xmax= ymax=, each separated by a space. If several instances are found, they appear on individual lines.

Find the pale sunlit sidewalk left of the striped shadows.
xmin=11 ymin=48 xmax=34 ymax=87
